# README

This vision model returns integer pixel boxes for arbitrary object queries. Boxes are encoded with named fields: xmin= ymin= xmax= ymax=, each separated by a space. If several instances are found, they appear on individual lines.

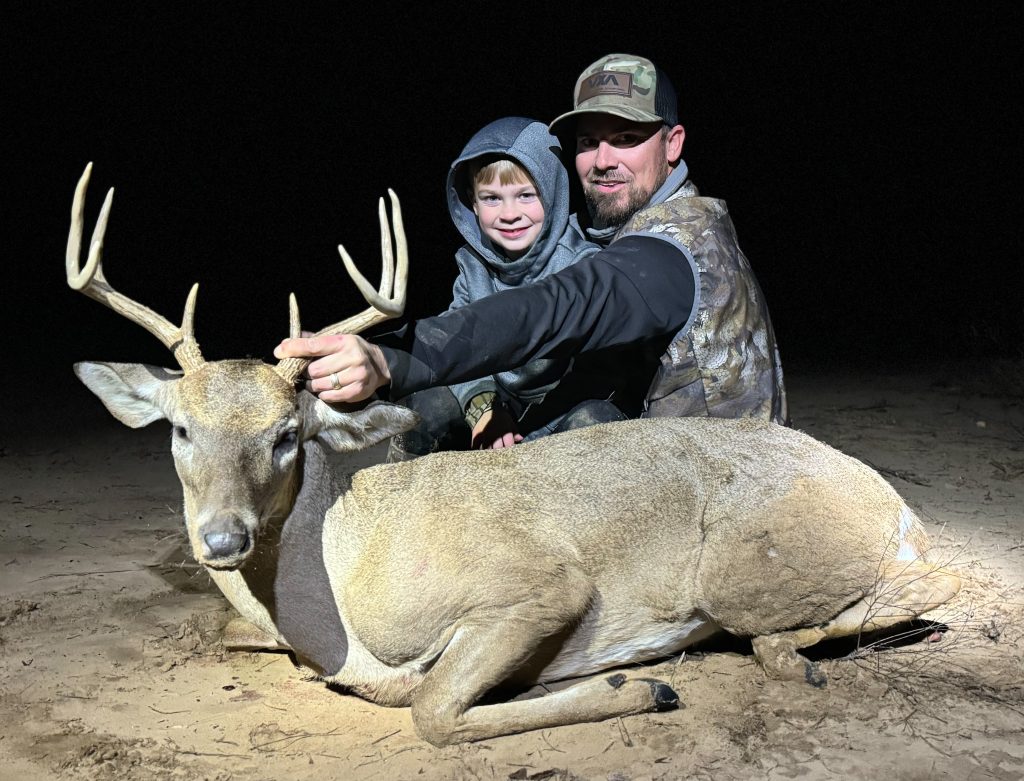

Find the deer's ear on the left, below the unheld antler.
xmin=75 ymin=361 xmax=181 ymax=429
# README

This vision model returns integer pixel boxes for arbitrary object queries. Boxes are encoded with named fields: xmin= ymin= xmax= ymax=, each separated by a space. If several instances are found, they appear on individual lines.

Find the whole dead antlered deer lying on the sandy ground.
xmin=67 ymin=163 xmax=959 ymax=745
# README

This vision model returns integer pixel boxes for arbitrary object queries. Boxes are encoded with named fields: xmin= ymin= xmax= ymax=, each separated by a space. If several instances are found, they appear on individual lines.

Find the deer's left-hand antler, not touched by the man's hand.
xmin=66 ymin=163 xmax=206 ymax=374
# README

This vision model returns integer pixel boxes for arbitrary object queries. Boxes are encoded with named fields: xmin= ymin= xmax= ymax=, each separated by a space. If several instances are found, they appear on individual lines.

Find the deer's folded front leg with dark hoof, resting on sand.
xmin=413 ymin=616 xmax=679 ymax=746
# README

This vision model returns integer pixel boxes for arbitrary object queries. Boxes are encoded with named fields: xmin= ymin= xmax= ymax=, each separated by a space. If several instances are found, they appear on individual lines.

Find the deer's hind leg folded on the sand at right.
xmin=753 ymin=561 xmax=959 ymax=687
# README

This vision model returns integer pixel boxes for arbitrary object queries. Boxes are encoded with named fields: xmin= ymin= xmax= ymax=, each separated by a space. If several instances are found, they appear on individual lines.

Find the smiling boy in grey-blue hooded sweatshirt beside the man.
xmin=388 ymin=117 xmax=625 ymax=461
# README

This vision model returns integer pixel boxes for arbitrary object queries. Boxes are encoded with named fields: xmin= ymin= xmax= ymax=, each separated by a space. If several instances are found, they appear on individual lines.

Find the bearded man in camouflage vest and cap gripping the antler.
xmin=274 ymin=54 xmax=788 ymax=434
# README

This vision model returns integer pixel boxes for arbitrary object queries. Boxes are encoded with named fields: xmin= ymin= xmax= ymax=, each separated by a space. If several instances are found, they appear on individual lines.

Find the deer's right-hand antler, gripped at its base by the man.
xmin=276 ymin=189 xmax=409 ymax=382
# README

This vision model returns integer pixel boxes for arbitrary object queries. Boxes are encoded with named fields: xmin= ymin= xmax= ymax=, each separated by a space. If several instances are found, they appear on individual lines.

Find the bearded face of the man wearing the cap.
xmin=575 ymin=114 xmax=683 ymax=227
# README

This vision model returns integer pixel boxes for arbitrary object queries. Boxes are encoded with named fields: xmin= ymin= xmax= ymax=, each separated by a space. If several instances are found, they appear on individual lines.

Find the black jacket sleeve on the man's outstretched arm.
xmin=374 ymin=234 xmax=694 ymax=399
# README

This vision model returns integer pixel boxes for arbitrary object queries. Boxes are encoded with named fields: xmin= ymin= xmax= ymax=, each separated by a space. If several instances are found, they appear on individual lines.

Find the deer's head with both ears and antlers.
xmin=67 ymin=163 xmax=417 ymax=569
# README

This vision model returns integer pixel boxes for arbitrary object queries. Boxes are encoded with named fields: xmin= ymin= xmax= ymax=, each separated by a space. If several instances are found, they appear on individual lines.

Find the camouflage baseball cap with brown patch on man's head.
xmin=548 ymin=54 xmax=679 ymax=133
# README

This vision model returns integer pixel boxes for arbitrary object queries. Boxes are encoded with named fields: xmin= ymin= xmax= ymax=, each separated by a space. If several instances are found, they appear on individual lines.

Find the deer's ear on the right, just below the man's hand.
xmin=299 ymin=391 xmax=420 ymax=452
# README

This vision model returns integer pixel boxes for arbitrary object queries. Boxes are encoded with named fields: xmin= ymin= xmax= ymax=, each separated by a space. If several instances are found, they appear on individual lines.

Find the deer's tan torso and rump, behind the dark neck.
xmin=311 ymin=419 xmax=924 ymax=691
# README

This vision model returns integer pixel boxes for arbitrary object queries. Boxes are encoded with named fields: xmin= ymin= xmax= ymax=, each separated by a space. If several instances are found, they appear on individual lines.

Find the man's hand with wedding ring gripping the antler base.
xmin=273 ymin=334 xmax=391 ymax=402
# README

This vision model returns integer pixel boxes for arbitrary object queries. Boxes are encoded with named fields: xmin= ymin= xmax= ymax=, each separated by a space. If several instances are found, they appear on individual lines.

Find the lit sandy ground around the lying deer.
xmin=0 ymin=371 xmax=1024 ymax=781
